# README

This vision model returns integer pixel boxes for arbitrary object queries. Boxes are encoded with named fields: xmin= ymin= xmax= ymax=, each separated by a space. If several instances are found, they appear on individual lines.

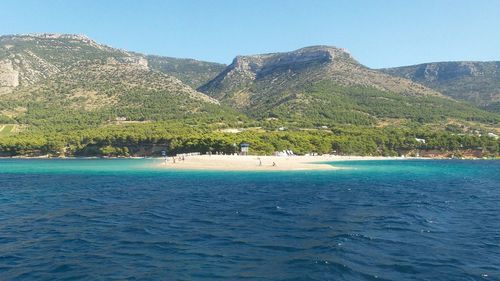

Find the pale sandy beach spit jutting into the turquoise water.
xmin=160 ymin=155 xmax=404 ymax=171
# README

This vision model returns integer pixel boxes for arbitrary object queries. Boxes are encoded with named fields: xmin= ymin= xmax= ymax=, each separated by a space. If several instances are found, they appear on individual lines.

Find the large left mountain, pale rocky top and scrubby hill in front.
xmin=0 ymin=34 xmax=238 ymax=126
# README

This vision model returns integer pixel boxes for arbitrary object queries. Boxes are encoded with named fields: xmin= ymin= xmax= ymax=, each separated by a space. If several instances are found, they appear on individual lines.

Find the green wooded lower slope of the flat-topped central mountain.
xmin=249 ymin=81 xmax=500 ymax=125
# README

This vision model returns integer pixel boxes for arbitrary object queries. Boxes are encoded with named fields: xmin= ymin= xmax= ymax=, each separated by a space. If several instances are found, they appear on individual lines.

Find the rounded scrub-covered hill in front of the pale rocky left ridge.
xmin=0 ymin=62 xmax=242 ymax=130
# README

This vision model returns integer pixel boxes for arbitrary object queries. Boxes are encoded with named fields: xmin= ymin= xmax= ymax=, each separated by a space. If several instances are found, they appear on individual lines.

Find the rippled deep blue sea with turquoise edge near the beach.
xmin=0 ymin=159 xmax=500 ymax=280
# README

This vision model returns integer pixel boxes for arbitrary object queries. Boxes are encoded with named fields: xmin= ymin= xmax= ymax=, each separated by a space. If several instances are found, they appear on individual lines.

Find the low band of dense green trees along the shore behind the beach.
xmin=0 ymin=122 xmax=500 ymax=156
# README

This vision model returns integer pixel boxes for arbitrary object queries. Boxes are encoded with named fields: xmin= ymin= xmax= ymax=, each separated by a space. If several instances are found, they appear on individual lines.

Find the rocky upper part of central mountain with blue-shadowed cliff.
xmin=199 ymin=46 xmax=440 ymax=107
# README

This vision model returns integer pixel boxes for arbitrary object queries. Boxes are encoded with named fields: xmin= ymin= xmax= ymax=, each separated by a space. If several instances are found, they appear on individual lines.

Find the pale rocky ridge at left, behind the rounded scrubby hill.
xmin=0 ymin=34 xmax=225 ymax=94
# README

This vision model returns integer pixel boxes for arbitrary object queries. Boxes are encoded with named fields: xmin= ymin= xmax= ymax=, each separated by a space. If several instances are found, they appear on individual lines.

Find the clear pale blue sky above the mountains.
xmin=0 ymin=0 xmax=500 ymax=68
